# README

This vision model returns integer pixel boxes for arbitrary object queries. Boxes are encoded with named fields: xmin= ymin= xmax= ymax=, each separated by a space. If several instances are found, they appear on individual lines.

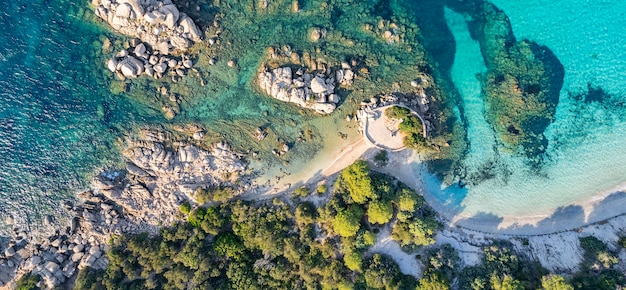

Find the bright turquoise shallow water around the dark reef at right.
xmin=426 ymin=0 xmax=626 ymax=223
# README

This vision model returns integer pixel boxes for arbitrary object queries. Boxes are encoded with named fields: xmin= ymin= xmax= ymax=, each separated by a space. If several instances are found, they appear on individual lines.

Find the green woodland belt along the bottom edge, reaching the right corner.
xmin=70 ymin=161 xmax=624 ymax=290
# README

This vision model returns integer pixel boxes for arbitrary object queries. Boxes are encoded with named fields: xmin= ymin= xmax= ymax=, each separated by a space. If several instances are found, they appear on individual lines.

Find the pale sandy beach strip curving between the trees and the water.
xmin=254 ymin=110 xmax=626 ymax=236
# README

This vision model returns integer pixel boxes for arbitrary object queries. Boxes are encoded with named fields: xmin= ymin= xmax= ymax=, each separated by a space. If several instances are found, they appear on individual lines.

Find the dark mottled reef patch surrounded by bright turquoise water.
xmin=446 ymin=0 xmax=565 ymax=167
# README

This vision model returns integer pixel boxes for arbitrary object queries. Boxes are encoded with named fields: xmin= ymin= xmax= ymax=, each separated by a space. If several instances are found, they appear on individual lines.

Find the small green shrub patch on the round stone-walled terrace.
xmin=385 ymin=106 xmax=426 ymax=150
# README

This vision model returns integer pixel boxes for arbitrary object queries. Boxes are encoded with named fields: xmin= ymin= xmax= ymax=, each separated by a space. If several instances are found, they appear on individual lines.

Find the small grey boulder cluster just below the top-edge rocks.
xmin=107 ymin=41 xmax=193 ymax=79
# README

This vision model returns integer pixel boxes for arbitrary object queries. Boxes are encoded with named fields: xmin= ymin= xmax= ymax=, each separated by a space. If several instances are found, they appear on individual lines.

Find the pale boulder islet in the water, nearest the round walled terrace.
xmin=258 ymin=64 xmax=354 ymax=114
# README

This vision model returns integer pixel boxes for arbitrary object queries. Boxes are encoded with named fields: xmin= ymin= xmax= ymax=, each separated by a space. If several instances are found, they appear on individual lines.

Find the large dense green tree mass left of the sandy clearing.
xmin=77 ymin=161 xmax=443 ymax=289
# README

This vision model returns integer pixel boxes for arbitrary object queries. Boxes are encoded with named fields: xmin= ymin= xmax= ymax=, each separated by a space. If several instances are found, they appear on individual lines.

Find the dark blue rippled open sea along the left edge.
xmin=0 ymin=1 xmax=158 ymax=230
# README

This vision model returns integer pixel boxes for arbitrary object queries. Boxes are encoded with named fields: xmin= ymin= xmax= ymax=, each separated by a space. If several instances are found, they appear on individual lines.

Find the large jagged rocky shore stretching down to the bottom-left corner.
xmin=0 ymin=130 xmax=247 ymax=289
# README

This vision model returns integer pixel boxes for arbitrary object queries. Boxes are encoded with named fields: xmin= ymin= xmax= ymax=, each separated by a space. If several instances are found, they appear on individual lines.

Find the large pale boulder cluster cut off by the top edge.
xmin=94 ymin=0 xmax=202 ymax=55
